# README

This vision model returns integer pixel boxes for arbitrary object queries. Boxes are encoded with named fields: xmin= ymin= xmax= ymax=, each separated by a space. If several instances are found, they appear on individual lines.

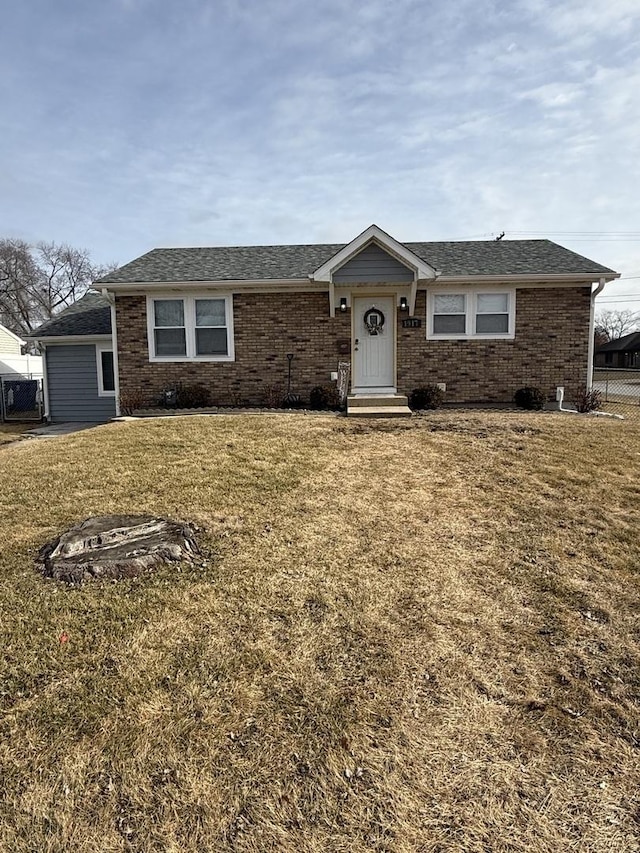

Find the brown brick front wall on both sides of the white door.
xmin=116 ymin=287 xmax=590 ymax=405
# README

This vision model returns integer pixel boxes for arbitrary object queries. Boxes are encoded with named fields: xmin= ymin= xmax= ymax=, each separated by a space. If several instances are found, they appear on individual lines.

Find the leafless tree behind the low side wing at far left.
xmin=0 ymin=239 xmax=113 ymax=335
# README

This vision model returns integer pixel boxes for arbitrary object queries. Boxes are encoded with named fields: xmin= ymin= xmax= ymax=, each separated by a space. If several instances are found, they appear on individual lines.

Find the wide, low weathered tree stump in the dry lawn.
xmin=36 ymin=515 xmax=200 ymax=584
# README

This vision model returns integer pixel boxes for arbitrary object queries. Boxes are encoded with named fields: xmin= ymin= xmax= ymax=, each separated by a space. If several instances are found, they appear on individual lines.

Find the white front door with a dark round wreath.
xmin=352 ymin=296 xmax=396 ymax=394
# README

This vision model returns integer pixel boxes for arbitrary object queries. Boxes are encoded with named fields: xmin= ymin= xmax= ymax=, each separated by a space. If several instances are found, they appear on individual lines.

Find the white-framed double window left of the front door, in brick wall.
xmin=147 ymin=293 xmax=234 ymax=361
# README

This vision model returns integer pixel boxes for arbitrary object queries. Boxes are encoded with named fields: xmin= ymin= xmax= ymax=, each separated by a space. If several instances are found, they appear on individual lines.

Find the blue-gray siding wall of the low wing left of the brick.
xmin=46 ymin=344 xmax=116 ymax=423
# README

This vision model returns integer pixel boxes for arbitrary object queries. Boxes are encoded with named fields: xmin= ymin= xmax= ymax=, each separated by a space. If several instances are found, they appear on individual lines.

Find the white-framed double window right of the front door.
xmin=427 ymin=290 xmax=516 ymax=340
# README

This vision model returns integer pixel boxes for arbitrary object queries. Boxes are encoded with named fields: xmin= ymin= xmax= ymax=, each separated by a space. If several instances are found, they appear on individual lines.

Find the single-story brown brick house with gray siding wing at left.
xmin=34 ymin=225 xmax=618 ymax=421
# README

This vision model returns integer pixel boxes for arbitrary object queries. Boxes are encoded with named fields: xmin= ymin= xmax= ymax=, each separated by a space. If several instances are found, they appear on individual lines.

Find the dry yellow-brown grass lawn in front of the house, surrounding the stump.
xmin=0 ymin=412 xmax=640 ymax=853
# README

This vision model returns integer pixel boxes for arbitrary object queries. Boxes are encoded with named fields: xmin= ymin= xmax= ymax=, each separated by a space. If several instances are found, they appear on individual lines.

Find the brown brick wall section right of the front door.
xmin=398 ymin=287 xmax=591 ymax=403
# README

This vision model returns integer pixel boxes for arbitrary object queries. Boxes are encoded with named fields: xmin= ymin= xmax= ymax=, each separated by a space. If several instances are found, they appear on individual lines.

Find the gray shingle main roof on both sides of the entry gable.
xmin=100 ymin=240 xmax=613 ymax=284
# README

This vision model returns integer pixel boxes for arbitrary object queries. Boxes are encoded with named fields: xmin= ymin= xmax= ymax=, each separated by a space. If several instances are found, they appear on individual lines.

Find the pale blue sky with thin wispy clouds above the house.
xmin=0 ymin=0 xmax=640 ymax=309
